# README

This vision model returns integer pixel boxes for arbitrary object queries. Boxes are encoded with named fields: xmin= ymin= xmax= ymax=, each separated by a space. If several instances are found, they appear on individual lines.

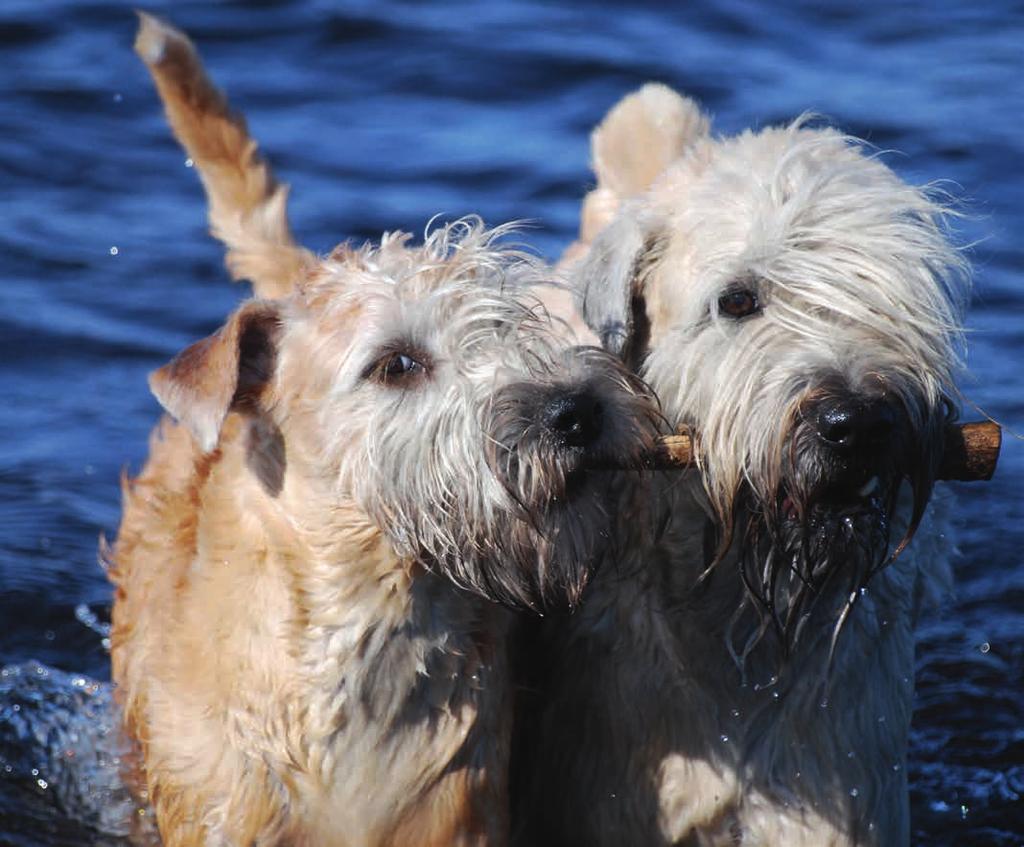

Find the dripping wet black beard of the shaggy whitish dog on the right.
xmin=712 ymin=410 xmax=948 ymax=668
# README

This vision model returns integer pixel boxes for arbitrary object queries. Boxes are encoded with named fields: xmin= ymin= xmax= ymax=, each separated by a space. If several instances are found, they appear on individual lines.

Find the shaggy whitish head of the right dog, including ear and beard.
xmin=577 ymin=117 xmax=966 ymax=634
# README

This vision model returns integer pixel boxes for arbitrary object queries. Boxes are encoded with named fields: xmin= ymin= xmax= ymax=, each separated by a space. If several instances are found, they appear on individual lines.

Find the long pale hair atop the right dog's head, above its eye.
xmin=652 ymin=125 xmax=955 ymax=310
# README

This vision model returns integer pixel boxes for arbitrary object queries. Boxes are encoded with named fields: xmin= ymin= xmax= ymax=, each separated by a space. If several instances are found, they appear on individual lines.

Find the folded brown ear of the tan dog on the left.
xmin=150 ymin=300 xmax=281 ymax=453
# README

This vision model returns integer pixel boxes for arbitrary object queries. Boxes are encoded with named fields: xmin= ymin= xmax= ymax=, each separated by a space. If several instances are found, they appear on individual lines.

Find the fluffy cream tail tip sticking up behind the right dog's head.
xmin=590 ymin=83 xmax=710 ymax=200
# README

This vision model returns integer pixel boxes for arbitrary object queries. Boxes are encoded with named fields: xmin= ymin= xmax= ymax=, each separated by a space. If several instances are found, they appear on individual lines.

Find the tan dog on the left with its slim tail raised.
xmin=109 ymin=15 xmax=656 ymax=847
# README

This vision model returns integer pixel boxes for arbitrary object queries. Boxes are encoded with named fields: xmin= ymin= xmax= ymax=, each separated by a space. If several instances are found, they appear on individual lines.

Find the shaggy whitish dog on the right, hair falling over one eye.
xmin=519 ymin=85 xmax=968 ymax=847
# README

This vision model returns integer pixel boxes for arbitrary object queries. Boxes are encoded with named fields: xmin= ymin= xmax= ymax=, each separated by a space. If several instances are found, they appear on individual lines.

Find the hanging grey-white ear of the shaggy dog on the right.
xmin=569 ymin=207 xmax=662 ymax=370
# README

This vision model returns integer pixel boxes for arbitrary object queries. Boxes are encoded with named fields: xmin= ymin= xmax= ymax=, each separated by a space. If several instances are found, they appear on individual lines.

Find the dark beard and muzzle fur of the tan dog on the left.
xmin=481 ymin=376 xmax=664 ymax=611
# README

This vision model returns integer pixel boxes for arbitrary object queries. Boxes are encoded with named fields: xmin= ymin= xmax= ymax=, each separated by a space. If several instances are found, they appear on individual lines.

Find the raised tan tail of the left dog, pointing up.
xmin=135 ymin=11 xmax=312 ymax=297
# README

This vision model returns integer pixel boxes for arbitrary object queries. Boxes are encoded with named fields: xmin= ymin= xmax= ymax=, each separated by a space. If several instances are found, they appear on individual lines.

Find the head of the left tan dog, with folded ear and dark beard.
xmin=154 ymin=226 xmax=657 ymax=606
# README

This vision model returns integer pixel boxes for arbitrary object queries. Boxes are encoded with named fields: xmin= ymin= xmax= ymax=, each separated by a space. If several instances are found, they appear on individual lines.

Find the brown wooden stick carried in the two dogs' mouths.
xmin=649 ymin=421 xmax=1002 ymax=482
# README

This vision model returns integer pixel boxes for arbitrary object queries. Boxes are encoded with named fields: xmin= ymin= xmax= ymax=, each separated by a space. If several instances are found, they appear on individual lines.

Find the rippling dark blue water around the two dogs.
xmin=0 ymin=0 xmax=1024 ymax=846
